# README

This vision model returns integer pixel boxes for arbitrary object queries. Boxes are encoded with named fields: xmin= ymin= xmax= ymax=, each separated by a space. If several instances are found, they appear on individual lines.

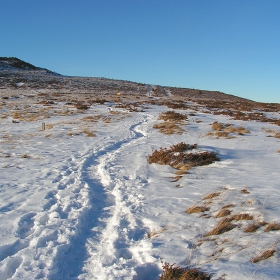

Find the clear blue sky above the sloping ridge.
xmin=0 ymin=0 xmax=280 ymax=103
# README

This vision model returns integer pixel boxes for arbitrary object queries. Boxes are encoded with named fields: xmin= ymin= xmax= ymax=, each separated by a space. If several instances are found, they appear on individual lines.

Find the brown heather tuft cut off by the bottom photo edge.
xmin=159 ymin=262 xmax=211 ymax=280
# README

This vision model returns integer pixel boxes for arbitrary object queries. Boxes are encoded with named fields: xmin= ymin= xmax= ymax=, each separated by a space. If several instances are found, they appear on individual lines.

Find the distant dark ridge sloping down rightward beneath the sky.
xmin=0 ymin=57 xmax=274 ymax=108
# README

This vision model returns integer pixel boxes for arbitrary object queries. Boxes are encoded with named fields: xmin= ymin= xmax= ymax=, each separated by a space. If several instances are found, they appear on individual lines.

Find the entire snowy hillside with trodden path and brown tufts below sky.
xmin=0 ymin=58 xmax=280 ymax=280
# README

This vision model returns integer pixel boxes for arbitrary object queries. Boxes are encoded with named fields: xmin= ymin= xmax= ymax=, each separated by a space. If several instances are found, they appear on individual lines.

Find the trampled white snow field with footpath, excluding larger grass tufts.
xmin=0 ymin=98 xmax=280 ymax=280
